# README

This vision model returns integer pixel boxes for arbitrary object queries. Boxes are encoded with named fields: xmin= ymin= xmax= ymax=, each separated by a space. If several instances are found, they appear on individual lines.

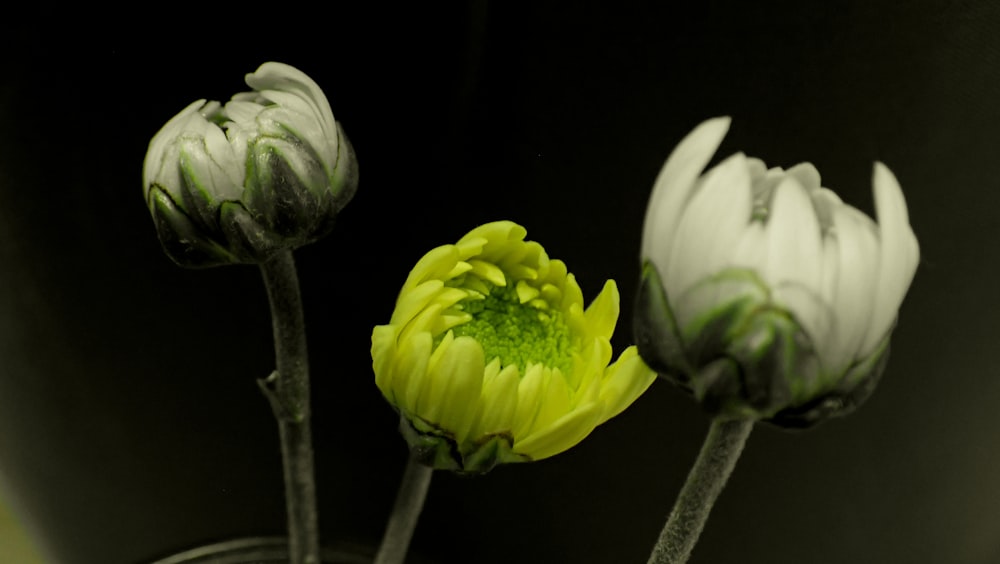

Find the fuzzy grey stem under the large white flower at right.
xmin=648 ymin=419 xmax=753 ymax=564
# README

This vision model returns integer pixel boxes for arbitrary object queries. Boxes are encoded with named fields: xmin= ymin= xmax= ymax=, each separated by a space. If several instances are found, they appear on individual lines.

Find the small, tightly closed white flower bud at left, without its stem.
xmin=142 ymin=63 xmax=358 ymax=267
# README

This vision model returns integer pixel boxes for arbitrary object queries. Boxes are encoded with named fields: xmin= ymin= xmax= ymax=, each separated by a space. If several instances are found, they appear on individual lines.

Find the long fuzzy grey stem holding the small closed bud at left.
xmin=258 ymin=251 xmax=319 ymax=564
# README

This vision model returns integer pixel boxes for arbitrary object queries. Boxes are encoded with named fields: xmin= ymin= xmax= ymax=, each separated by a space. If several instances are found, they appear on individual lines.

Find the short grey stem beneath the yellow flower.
xmin=375 ymin=455 xmax=434 ymax=564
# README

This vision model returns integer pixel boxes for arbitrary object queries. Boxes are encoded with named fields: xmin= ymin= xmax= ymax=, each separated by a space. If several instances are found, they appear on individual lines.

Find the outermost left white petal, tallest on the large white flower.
xmin=642 ymin=117 xmax=731 ymax=274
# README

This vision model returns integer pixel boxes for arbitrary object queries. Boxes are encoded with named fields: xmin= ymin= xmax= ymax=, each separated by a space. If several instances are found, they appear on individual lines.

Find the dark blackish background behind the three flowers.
xmin=0 ymin=4 xmax=1000 ymax=564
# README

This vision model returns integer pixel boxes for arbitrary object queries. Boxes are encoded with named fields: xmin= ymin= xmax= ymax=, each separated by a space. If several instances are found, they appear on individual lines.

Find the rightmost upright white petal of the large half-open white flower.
xmin=861 ymin=162 xmax=920 ymax=354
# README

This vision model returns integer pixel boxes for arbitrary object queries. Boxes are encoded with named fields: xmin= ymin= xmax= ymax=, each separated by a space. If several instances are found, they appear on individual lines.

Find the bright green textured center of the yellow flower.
xmin=454 ymin=281 xmax=573 ymax=375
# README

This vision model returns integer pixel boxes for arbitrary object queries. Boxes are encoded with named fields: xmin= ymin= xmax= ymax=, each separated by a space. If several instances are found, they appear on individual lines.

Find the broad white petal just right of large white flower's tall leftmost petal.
xmin=660 ymin=153 xmax=753 ymax=300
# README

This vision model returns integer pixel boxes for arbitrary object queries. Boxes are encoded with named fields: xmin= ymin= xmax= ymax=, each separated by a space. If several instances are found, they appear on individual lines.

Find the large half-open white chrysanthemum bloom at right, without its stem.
xmin=635 ymin=118 xmax=920 ymax=427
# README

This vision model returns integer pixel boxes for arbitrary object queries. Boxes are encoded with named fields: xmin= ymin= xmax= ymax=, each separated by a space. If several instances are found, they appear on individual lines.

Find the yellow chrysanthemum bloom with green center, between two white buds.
xmin=372 ymin=221 xmax=655 ymax=473
